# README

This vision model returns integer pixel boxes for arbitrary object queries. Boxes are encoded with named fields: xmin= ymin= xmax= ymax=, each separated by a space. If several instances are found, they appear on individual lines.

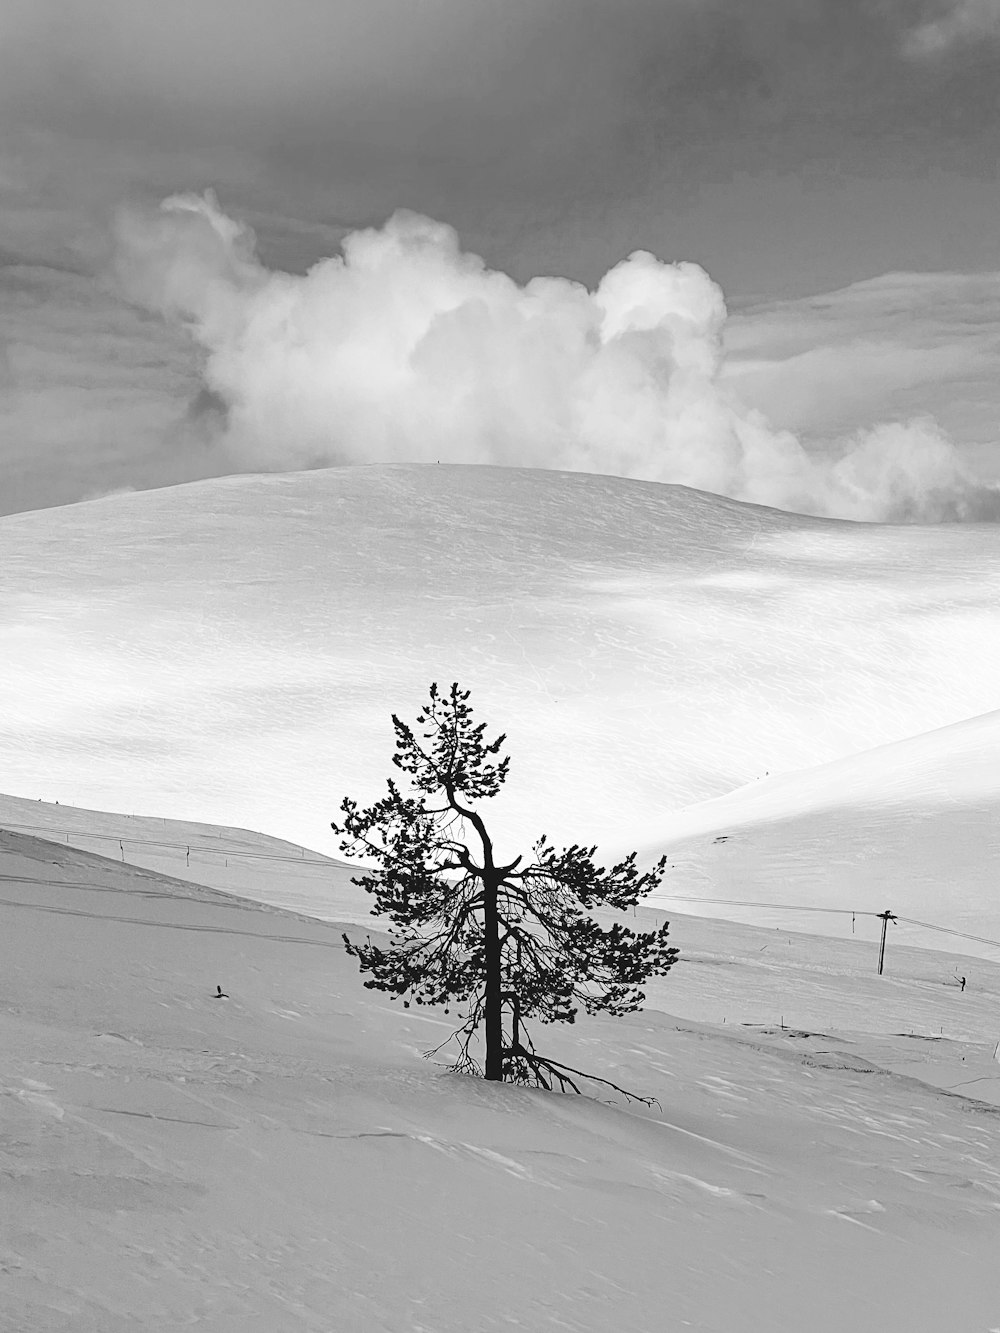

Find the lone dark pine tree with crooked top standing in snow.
xmin=332 ymin=684 xmax=677 ymax=1101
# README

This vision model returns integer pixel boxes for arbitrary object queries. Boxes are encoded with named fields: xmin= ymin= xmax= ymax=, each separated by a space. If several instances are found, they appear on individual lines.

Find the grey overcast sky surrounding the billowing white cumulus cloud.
xmin=0 ymin=0 xmax=1000 ymax=512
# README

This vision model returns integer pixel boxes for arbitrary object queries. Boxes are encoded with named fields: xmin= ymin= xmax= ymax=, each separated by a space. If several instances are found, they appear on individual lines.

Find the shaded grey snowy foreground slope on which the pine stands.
xmin=0 ymin=822 xmax=1000 ymax=1333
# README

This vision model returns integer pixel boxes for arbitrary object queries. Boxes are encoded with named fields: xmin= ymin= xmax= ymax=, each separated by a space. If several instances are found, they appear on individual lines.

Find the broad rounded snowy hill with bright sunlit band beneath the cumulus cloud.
xmin=0 ymin=465 xmax=1000 ymax=852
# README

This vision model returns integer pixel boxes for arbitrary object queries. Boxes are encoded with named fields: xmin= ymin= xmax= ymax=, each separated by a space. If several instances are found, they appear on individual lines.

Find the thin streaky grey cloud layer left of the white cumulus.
xmin=0 ymin=254 xmax=217 ymax=515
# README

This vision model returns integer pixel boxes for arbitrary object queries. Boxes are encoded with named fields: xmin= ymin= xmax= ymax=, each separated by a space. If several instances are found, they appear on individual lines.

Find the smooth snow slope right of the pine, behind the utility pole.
xmin=645 ymin=712 xmax=1000 ymax=960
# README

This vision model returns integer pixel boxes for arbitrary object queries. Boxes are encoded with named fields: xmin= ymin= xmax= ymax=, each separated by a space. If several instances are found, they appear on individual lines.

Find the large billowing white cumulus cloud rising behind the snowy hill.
xmin=117 ymin=193 xmax=1000 ymax=521
